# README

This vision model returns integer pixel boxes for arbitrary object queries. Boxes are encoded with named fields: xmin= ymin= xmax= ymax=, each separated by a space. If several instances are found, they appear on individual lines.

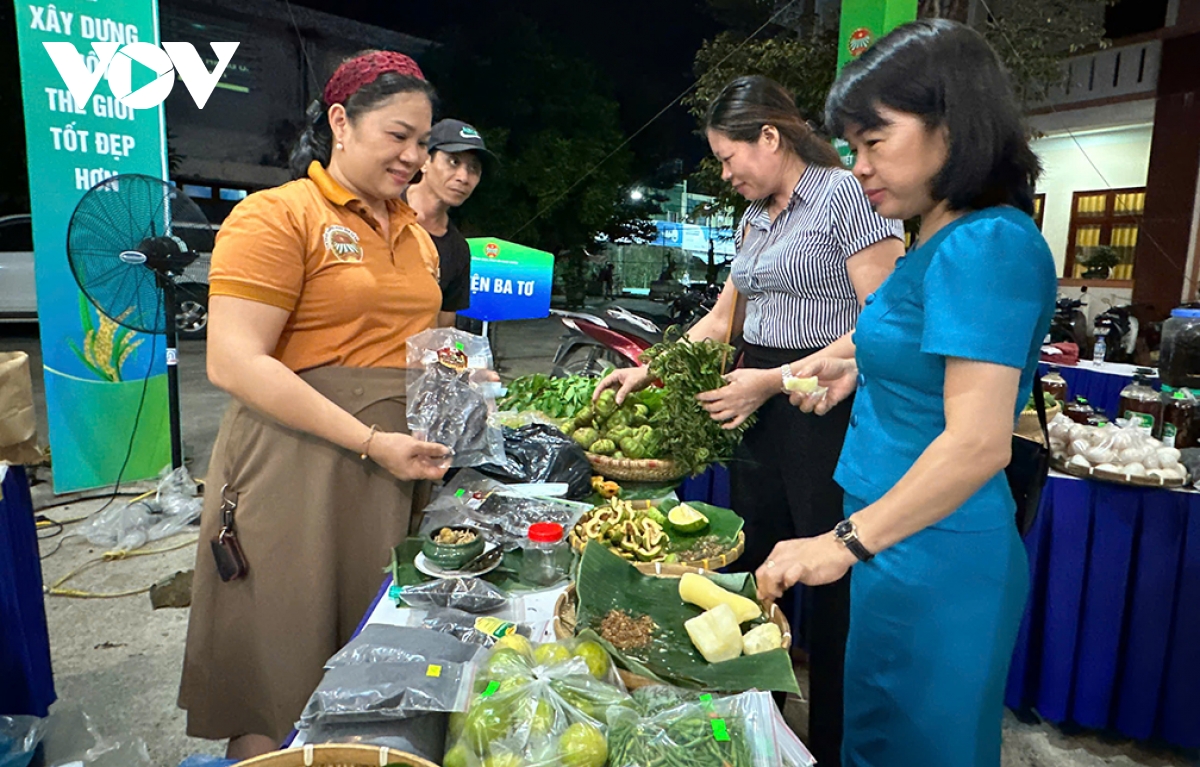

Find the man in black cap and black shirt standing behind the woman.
xmin=403 ymin=120 xmax=494 ymax=328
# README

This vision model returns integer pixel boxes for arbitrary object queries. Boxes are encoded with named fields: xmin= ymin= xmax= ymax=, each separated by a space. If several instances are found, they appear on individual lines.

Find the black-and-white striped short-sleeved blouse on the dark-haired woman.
xmin=730 ymin=164 xmax=904 ymax=349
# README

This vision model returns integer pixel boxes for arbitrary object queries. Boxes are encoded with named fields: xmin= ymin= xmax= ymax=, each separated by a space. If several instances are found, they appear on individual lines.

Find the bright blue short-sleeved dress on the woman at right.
xmin=835 ymin=208 xmax=1057 ymax=767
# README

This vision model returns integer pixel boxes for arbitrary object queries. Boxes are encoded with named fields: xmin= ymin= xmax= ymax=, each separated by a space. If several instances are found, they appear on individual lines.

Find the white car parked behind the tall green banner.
xmin=0 ymin=214 xmax=209 ymax=338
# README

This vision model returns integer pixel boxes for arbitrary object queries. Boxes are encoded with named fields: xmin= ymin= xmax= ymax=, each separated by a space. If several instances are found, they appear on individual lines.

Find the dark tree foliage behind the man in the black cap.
xmin=428 ymin=14 xmax=653 ymax=261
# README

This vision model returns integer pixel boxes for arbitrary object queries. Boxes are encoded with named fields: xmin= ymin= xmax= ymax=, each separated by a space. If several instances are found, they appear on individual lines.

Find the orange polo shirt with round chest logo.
xmin=209 ymin=162 xmax=442 ymax=371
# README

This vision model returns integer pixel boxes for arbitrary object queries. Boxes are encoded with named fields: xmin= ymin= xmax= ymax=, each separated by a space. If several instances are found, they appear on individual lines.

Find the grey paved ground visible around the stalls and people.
xmin=0 ymin=312 xmax=1200 ymax=767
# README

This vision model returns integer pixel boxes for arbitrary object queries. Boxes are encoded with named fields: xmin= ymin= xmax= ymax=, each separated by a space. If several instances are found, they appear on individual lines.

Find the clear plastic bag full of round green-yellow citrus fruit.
xmin=442 ymin=640 xmax=636 ymax=767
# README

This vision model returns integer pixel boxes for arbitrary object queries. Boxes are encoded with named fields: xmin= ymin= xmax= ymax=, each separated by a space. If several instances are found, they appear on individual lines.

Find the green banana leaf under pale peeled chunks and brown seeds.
xmin=575 ymin=543 xmax=799 ymax=694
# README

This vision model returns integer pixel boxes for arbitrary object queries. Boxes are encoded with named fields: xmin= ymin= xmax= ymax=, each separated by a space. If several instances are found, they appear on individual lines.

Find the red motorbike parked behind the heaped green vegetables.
xmin=550 ymin=305 xmax=662 ymax=378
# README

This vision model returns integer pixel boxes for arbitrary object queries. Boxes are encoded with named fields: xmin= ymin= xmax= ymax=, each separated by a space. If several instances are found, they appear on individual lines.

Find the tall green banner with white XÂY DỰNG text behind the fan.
xmin=16 ymin=0 xmax=174 ymax=492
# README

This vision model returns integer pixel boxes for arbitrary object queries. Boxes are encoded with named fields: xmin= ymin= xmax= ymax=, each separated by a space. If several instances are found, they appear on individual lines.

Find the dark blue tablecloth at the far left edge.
xmin=0 ymin=466 xmax=55 ymax=717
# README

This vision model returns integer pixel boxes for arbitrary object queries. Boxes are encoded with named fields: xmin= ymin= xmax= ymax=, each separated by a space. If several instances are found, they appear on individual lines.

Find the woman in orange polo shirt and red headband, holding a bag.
xmin=179 ymin=52 xmax=448 ymax=759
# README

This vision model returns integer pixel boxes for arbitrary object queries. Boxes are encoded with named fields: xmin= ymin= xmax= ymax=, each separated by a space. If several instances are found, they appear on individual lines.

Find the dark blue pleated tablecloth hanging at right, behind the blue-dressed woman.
xmin=1006 ymin=477 xmax=1200 ymax=748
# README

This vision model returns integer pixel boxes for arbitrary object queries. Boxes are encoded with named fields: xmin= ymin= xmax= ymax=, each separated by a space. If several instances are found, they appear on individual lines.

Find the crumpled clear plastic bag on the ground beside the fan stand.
xmin=74 ymin=467 xmax=204 ymax=551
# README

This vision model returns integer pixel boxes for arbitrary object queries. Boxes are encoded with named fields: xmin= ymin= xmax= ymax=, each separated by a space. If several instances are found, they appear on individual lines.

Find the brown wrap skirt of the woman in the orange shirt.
xmin=179 ymin=367 xmax=413 ymax=741
